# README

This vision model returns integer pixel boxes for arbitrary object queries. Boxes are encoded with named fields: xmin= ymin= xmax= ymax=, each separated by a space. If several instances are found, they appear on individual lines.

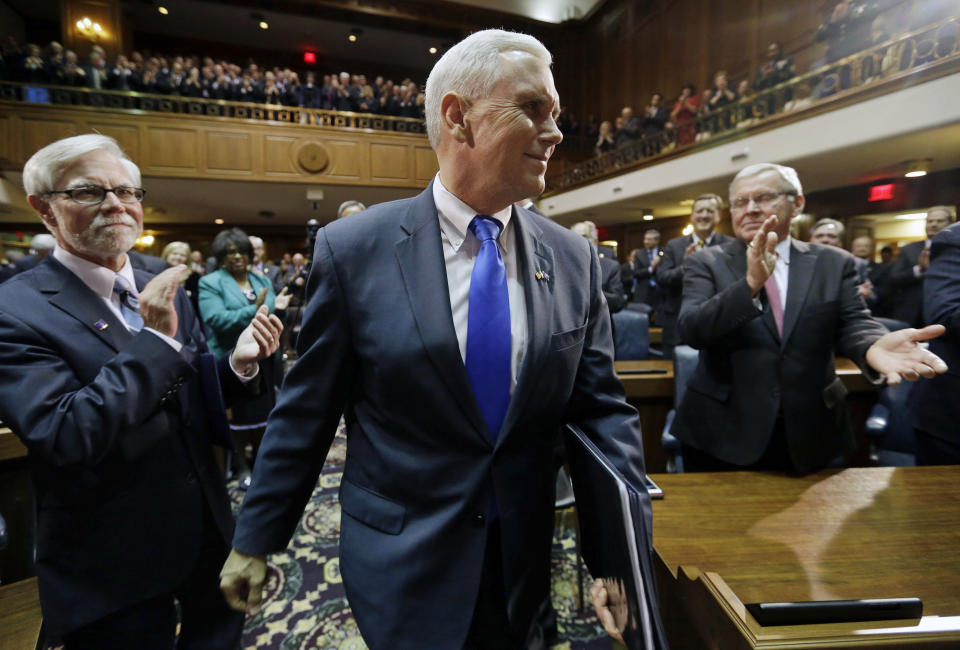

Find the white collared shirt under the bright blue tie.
xmin=433 ymin=174 xmax=527 ymax=394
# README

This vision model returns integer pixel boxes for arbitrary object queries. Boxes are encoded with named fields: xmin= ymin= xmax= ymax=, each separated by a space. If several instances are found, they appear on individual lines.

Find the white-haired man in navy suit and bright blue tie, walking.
xmin=221 ymin=30 xmax=649 ymax=649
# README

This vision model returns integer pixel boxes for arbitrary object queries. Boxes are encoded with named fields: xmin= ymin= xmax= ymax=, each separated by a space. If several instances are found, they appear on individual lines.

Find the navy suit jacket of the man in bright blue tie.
xmin=234 ymin=187 xmax=645 ymax=650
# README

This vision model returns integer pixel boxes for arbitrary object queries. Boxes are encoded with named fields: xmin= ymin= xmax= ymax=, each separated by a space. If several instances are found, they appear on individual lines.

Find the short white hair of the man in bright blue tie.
xmin=426 ymin=29 xmax=553 ymax=150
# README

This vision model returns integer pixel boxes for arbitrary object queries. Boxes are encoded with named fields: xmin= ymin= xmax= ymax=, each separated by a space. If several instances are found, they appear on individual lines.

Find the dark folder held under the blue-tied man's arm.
xmin=565 ymin=425 xmax=668 ymax=650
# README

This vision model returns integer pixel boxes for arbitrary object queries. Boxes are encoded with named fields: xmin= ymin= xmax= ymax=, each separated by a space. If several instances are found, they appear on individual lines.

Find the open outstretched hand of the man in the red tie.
xmin=866 ymin=325 xmax=947 ymax=386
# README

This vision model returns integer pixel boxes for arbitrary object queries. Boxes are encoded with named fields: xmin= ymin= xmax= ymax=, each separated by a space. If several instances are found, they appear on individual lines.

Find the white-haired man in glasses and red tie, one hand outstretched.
xmin=673 ymin=164 xmax=946 ymax=472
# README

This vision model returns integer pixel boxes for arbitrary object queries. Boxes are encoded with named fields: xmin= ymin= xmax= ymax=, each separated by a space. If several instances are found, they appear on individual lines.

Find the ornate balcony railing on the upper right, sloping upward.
xmin=547 ymin=16 xmax=960 ymax=193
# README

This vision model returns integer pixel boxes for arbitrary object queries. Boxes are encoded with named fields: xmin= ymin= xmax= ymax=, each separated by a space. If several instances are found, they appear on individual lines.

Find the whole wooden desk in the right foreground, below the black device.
xmin=653 ymin=467 xmax=960 ymax=650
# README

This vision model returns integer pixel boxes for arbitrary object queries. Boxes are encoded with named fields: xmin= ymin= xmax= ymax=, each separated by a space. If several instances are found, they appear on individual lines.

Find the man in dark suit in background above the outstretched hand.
xmin=889 ymin=205 xmax=956 ymax=327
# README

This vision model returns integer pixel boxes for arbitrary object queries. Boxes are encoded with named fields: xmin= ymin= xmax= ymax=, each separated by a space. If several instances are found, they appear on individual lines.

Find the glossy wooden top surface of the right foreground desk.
xmin=653 ymin=467 xmax=960 ymax=647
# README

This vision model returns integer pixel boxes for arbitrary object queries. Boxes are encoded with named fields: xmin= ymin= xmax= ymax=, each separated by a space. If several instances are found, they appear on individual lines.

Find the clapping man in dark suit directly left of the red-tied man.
xmin=656 ymin=194 xmax=733 ymax=359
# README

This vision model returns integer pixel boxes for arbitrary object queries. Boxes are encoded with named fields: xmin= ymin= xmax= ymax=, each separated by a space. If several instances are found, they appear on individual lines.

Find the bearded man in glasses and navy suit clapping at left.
xmin=0 ymin=135 xmax=280 ymax=650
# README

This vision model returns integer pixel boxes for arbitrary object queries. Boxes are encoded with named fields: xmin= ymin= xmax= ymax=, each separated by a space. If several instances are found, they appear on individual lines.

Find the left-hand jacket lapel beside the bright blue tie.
xmin=396 ymin=183 xmax=490 ymax=444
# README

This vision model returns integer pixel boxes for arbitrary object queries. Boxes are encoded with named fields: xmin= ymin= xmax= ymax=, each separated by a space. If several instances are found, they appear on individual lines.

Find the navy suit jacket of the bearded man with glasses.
xmin=0 ymin=256 xmax=243 ymax=636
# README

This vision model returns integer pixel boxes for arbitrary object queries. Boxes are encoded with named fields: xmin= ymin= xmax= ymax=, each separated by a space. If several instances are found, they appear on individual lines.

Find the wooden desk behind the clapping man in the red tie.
xmin=614 ymin=358 xmax=876 ymax=473
